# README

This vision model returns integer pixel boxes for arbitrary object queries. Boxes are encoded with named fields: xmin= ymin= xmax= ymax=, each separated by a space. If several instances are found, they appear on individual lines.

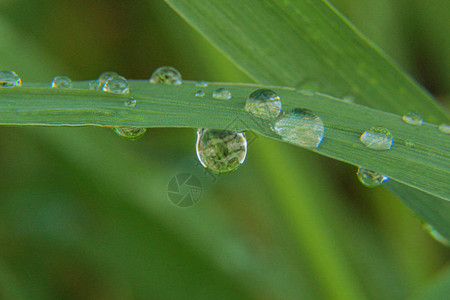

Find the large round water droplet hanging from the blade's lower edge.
xmin=196 ymin=128 xmax=248 ymax=174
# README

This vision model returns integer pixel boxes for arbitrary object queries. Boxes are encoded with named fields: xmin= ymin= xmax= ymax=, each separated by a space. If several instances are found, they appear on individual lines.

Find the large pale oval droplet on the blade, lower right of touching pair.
xmin=273 ymin=108 xmax=325 ymax=148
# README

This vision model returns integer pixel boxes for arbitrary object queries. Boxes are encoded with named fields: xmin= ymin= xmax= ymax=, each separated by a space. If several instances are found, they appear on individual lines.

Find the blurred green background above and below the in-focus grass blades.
xmin=0 ymin=0 xmax=450 ymax=299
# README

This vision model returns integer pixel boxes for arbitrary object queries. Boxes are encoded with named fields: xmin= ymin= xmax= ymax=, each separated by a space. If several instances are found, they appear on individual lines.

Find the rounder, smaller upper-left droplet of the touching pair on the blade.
xmin=245 ymin=89 xmax=281 ymax=119
